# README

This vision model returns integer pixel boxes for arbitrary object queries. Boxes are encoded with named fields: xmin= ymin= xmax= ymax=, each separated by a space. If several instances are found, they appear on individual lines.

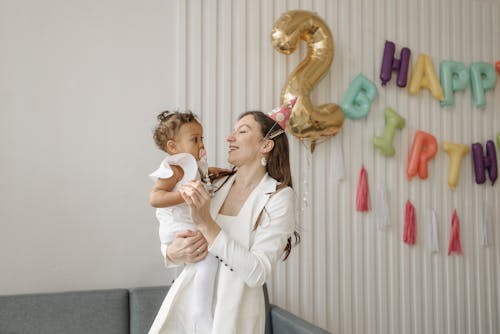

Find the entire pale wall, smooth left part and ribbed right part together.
xmin=0 ymin=0 xmax=500 ymax=334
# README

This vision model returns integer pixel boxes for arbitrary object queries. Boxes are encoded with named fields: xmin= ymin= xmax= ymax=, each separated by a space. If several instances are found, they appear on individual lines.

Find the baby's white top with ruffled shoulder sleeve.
xmin=149 ymin=153 xmax=200 ymax=247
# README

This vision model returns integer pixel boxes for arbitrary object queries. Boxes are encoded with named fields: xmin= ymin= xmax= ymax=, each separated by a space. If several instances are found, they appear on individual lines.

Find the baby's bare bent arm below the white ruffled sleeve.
xmin=149 ymin=165 xmax=184 ymax=208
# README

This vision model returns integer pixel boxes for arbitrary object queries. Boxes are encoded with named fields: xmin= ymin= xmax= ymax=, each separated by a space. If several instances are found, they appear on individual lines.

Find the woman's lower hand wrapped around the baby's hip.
xmin=167 ymin=230 xmax=208 ymax=263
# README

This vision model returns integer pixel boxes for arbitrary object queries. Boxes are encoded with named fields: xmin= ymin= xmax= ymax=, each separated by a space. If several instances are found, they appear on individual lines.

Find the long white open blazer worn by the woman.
xmin=149 ymin=174 xmax=295 ymax=334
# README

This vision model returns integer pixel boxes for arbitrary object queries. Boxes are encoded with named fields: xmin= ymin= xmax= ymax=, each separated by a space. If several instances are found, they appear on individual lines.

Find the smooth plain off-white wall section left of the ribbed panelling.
xmin=0 ymin=0 xmax=177 ymax=294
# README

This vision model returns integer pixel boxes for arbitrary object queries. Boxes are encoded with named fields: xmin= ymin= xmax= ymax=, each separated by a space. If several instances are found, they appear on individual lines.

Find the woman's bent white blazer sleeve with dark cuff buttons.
xmin=209 ymin=187 xmax=295 ymax=287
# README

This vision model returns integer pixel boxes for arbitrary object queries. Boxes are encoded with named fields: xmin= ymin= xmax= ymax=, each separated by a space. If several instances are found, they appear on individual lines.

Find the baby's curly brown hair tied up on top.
xmin=153 ymin=110 xmax=200 ymax=153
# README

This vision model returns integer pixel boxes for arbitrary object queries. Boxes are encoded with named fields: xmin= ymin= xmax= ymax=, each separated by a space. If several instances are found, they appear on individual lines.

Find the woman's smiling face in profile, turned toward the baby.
xmin=226 ymin=115 xmax=263 ymax=167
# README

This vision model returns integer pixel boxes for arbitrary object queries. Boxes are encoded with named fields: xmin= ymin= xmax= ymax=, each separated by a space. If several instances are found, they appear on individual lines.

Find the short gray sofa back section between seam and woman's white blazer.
xmin=130 ymin=286 xmax=170 ymax=334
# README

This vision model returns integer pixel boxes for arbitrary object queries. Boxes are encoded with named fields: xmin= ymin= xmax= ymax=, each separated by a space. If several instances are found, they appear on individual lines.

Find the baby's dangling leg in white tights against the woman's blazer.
xmin=194 ymin=253 xmax=218 ymax=334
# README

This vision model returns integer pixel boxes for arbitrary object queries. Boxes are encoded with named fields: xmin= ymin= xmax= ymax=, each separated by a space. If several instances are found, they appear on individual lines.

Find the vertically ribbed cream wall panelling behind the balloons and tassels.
xmin=175 ymin=0 xmax=500 ymax=334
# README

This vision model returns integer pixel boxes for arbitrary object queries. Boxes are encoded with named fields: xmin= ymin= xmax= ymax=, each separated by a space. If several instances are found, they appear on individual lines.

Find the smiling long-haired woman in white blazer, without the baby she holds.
xmin=150 ymin=112 xmax=299 ymax=334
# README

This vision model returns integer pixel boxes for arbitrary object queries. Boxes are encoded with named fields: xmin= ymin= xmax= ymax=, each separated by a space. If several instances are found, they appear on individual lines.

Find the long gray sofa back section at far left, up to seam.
xmin=0 ymin=289 xmax=129 ymax=334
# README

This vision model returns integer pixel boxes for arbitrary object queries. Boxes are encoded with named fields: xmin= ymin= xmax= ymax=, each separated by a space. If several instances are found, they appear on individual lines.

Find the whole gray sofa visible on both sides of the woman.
xmin=0 ymin=286 xmax=328 ymax=334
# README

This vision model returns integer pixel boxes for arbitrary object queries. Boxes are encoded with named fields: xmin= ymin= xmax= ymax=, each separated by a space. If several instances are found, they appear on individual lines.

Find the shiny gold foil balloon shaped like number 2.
xmin=271 ymin=10 xmax=344 ymax=152
